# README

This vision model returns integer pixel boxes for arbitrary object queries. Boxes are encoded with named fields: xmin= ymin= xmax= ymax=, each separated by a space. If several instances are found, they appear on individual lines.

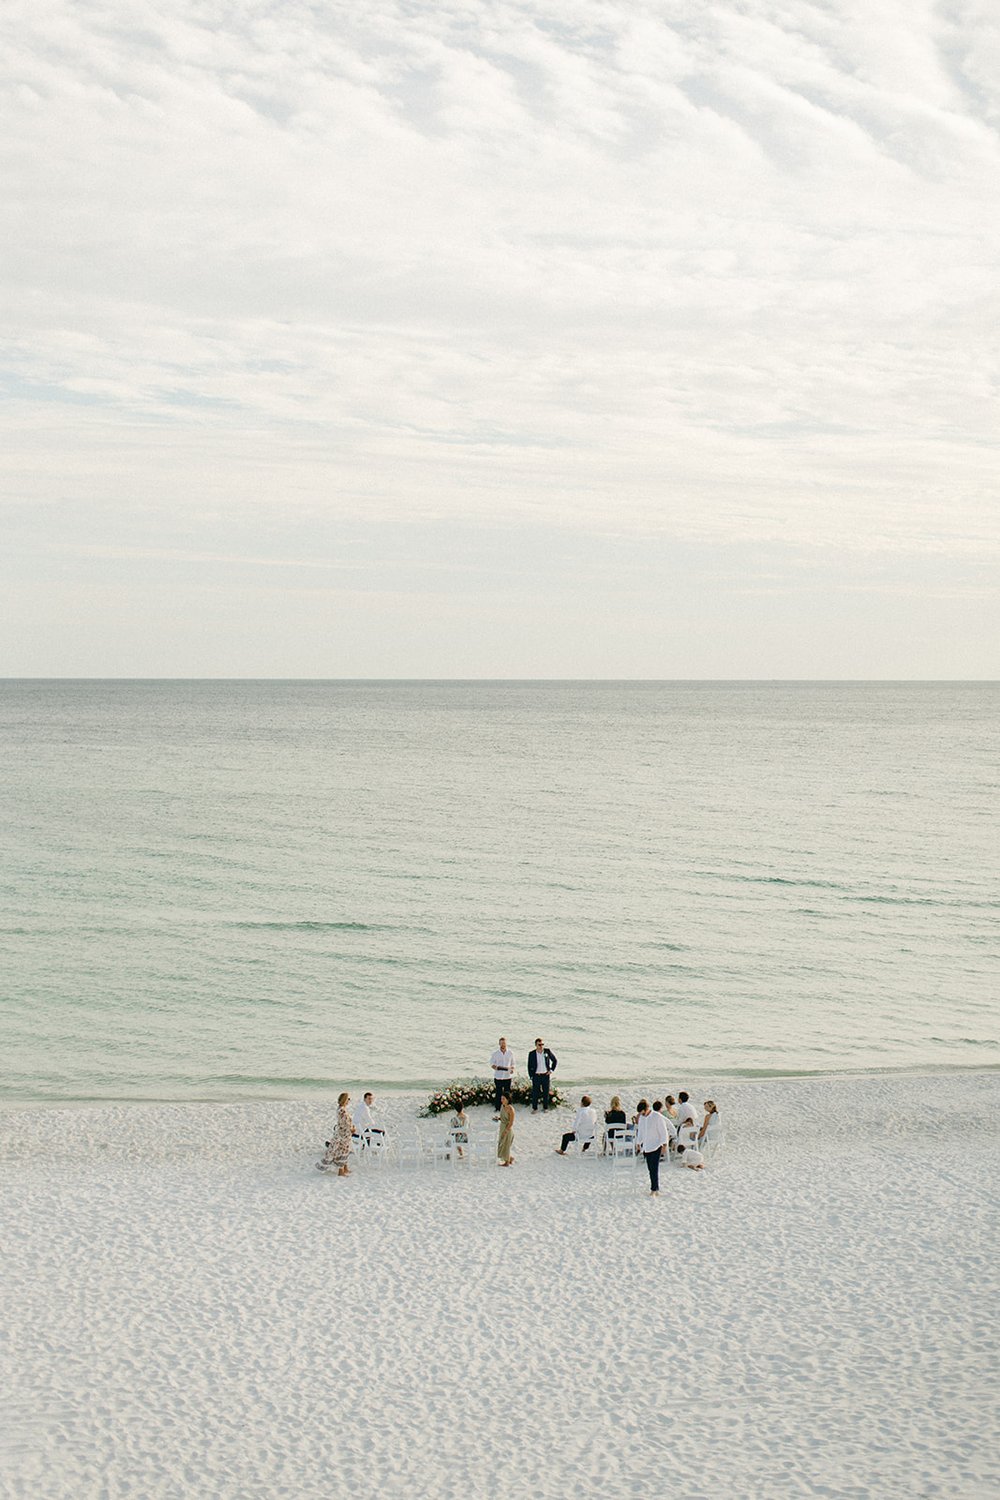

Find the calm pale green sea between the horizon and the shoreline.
xmin=0 ymin=681 xmax=1000 ymax=1100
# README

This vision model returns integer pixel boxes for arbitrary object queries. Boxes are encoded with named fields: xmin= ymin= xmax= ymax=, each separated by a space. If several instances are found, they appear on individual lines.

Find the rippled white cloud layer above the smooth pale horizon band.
xmin=0 ymin=0 xmax=1000 ymax=669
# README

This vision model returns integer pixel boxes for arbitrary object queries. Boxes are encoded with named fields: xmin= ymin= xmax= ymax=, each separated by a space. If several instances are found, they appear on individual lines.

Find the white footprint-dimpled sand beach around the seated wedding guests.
xmin=0 ymin=1073 xmax=1000 ymax=1500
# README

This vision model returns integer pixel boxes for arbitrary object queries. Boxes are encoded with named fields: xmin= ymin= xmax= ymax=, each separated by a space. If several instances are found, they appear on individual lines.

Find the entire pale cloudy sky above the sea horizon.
xmin=0 ymin=0 xmax=1000 ymax=678
